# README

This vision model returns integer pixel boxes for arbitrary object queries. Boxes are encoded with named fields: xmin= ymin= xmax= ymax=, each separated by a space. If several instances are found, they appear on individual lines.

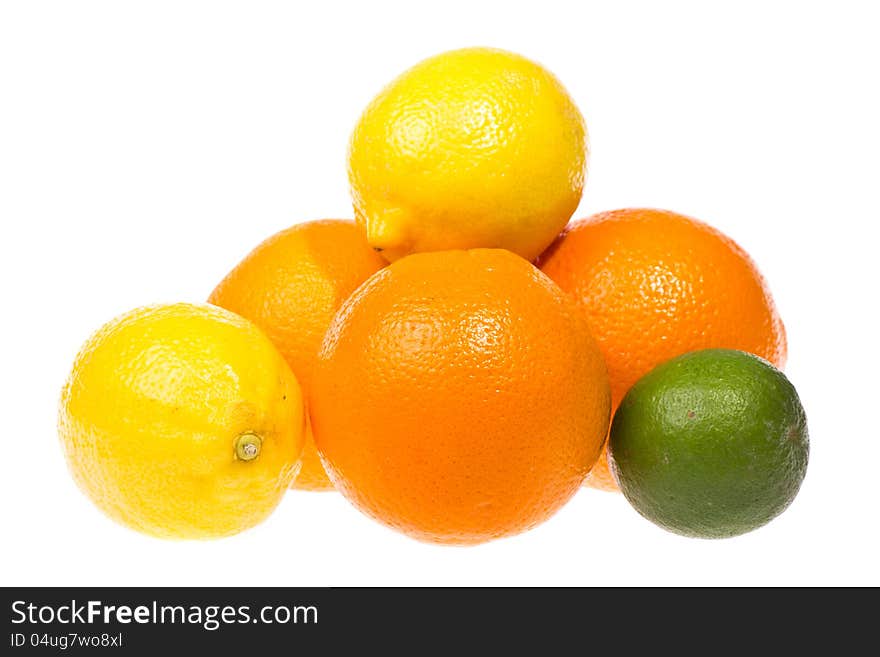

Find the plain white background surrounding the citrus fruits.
xmin=0 ymin=0 xmax=880 ymax=586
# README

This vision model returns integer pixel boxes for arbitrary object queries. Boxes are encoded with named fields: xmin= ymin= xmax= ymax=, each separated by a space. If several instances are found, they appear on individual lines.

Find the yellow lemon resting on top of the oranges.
xmin=348 ymin=48 xmax=588 ymax=261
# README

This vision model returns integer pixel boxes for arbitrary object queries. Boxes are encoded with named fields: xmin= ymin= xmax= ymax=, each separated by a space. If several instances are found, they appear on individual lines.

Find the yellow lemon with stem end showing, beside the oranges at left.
xmin=59 ymin=304 xmax=305 ymax=538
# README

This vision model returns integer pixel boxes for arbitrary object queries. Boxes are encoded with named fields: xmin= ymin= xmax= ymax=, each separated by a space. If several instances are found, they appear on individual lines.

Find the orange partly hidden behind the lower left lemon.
xmin=208 ymin=219 xmax=387 ymax=490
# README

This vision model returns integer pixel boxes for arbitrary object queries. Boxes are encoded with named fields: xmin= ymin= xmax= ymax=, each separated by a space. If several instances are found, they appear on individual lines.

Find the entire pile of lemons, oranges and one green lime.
xmin=59 ymin=48 xmax=809 ymax=545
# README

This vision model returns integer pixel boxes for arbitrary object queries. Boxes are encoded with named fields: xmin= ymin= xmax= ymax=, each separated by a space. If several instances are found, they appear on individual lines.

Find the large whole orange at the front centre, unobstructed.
xmin=312 ymin=249 xmax=610 ymax=544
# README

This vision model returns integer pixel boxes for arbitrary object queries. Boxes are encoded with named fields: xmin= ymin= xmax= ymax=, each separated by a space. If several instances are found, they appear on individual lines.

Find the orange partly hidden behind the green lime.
xmin=538 ymin=209 xmax=786 ymax=490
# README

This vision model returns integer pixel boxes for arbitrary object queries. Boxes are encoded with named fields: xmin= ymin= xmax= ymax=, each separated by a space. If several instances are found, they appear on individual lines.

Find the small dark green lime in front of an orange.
xmin=609 ymin=349 xmax=810 ymax=538
